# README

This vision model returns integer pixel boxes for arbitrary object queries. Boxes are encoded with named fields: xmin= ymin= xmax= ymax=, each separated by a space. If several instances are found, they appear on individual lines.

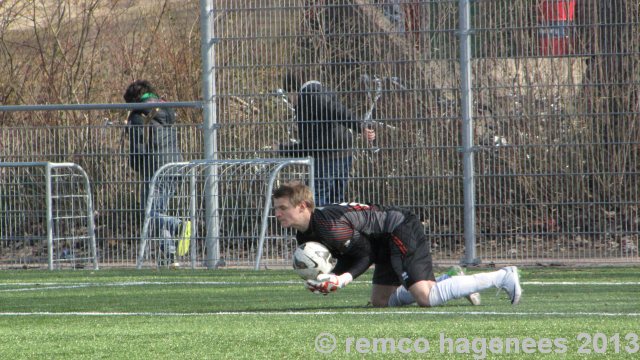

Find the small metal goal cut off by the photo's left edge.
xmin=0 ymin=163 xmax=98 ymax=269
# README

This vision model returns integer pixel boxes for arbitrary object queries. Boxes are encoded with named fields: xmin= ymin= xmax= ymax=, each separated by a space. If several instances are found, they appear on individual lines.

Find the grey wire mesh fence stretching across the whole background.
xmin=0 ymin=0 xmax=640 ymax=267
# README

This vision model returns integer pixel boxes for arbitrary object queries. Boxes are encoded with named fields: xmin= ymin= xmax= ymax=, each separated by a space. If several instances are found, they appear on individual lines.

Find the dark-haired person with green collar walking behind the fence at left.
xmin=124 ymin=80 xmax=182 ymax=266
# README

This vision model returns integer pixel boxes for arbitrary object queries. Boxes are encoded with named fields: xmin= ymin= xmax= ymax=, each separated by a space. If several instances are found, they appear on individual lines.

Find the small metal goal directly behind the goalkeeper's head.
xmin=137 ymin=158 xmax=314 ymax=269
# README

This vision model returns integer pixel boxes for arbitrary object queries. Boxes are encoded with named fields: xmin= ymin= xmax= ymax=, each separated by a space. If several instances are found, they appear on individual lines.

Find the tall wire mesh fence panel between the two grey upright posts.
xmin=215 ymin=0 xmax=464 ymax=262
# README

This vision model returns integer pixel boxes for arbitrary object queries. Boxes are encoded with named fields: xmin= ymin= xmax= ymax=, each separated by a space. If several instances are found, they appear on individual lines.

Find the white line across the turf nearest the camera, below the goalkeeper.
xmin=0 ymin=310 xmax=640 ymax=317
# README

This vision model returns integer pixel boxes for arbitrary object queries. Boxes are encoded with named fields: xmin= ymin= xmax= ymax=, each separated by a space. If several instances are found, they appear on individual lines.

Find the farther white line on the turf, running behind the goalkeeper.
xmin=0 ymin=280 xmax=640 ymax=292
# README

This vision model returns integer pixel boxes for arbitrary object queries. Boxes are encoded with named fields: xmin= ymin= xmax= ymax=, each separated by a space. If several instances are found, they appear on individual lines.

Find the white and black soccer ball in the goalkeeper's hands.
xmin=293 ymin=241 xmax=333 ymax=280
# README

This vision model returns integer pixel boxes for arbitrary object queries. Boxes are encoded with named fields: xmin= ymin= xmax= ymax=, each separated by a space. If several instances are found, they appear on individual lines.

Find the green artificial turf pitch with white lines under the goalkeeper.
xmin=0 ymin=267 xmax=640 ymax=359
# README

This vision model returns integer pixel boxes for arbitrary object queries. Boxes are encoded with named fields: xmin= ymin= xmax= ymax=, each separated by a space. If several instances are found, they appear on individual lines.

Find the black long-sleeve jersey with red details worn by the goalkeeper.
xmin=296 ymin=203 xmax=424 ymax=278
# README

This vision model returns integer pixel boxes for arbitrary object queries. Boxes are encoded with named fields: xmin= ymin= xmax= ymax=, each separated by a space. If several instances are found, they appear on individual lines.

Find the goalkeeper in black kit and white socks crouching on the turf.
xmin=273 ymin=182 xmax=522 ymax=307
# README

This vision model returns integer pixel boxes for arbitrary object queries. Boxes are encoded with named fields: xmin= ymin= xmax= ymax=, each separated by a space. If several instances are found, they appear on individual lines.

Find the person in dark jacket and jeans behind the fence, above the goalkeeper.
xmin=276 ymin=72 xmax=375 ymax=205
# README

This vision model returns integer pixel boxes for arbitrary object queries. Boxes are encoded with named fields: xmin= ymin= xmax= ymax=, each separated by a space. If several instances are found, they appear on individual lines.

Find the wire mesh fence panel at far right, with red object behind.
xmin=472 ymin=0 xmax=640 ymax=264
